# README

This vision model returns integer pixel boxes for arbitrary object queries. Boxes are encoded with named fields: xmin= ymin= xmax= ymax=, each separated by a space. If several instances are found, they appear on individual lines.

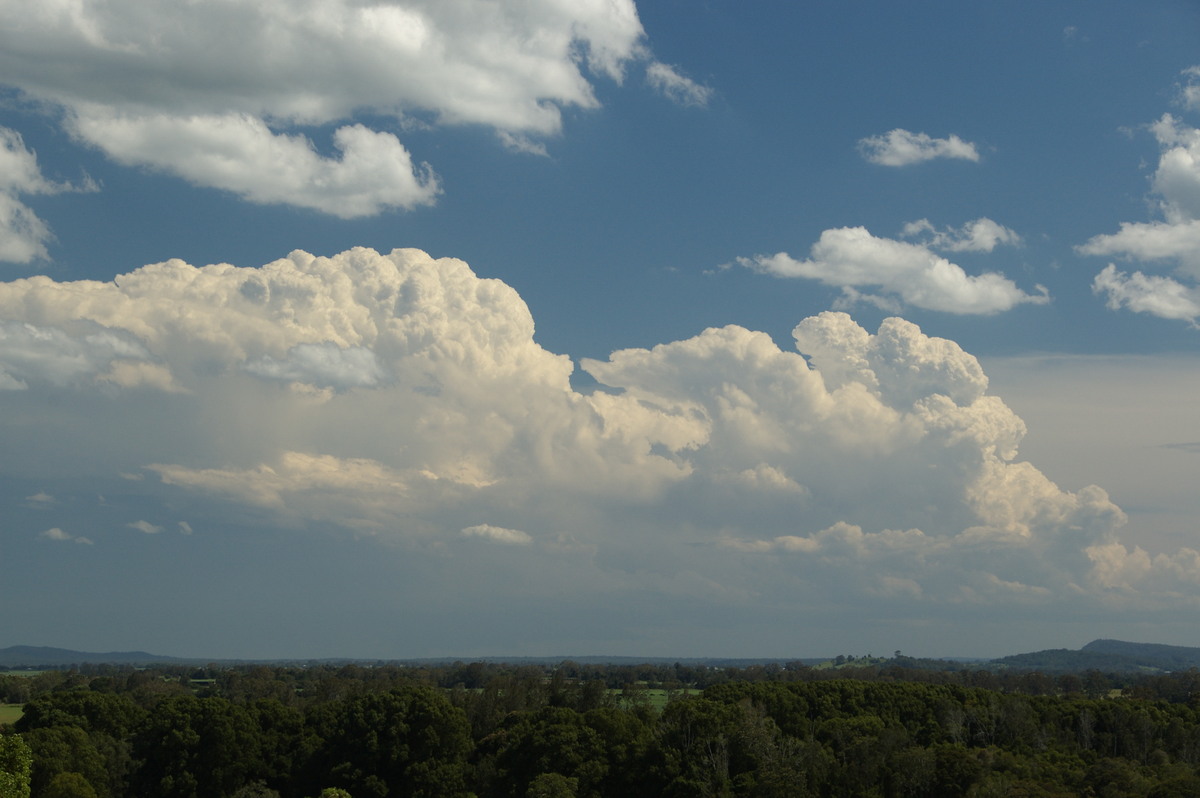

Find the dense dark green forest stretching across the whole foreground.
xmin=0 ymin=656 xmax=1200 ymax=798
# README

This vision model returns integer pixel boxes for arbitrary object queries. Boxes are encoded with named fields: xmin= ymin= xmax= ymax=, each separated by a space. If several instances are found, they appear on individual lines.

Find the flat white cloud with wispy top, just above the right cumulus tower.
xmin=738 ymin=225 xmax=1049 ymax=314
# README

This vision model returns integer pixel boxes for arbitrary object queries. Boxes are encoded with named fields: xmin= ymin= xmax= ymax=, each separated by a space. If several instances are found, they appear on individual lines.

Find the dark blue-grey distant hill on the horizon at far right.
xmin=989 ymin=640 xmax=1200 ymax=673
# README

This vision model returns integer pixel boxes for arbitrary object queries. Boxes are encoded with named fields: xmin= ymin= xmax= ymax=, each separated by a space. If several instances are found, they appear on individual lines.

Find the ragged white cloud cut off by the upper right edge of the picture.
xmin=1076 ymin=73 xmax=1200 ymax=323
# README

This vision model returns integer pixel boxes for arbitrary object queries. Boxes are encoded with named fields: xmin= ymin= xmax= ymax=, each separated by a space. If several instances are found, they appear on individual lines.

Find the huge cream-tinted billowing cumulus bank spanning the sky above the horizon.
xmin=0 ymin=246 xmax=1194 ymax=612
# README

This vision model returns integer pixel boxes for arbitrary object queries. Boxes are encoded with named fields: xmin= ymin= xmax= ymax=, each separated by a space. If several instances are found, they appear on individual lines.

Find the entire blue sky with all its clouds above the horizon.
xmin=0 ymin=0 xmax=1200 ymax=659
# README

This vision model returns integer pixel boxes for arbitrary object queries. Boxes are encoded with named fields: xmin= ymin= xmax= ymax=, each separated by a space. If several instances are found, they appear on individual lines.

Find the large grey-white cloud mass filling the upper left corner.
xmin=0 ymin=0 xmax=657 ymax=216
